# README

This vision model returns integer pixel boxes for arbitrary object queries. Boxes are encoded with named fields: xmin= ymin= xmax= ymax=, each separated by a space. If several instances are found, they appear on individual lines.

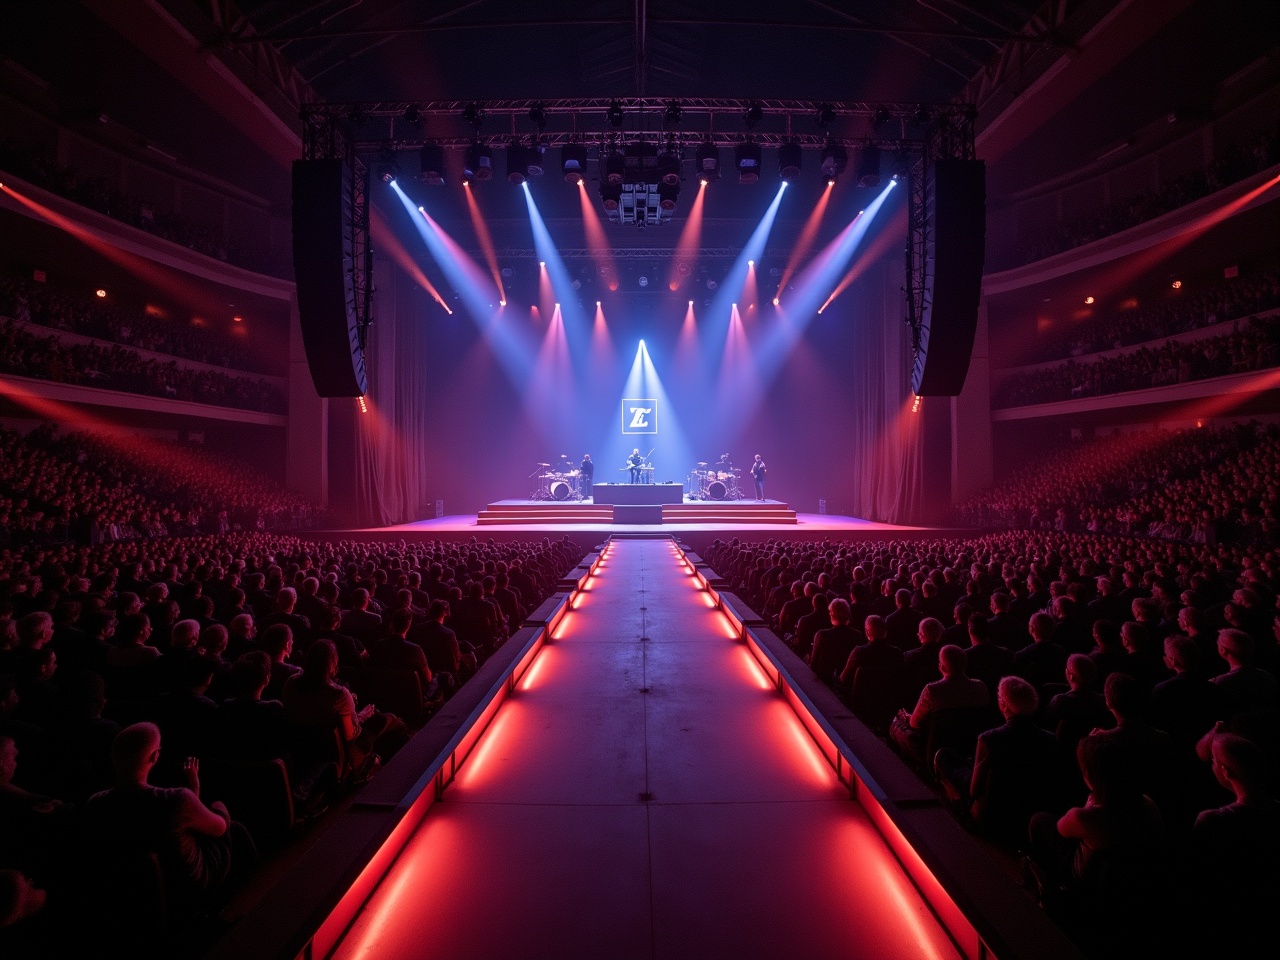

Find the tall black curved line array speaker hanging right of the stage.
xmin=911 ymin=160 xmax=987 ymax=397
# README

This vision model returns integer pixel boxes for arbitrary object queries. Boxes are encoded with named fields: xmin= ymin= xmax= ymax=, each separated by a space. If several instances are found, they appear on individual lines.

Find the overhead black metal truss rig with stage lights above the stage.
xmin=301 ymin=97 xmax=977 ymax=376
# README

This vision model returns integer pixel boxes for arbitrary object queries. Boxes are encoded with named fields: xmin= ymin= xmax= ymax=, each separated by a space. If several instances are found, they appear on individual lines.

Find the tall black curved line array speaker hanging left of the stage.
xmin=293 ymin=160 xmax=367 ymax=397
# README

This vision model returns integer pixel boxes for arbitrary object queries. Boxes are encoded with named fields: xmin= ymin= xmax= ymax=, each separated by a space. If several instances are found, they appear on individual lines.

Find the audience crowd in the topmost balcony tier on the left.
xmin=0 ymin=141 xmax=281 ymax=271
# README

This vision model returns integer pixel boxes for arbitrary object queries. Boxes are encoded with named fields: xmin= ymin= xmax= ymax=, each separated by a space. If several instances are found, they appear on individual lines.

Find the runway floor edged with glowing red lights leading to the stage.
xmin=335 ymin=540 xmax=959 ymax=960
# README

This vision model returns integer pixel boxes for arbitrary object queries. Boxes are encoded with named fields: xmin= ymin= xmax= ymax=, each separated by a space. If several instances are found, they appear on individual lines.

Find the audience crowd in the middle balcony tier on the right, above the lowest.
xmin=997 ymin=269 xmax=1280 ymax=366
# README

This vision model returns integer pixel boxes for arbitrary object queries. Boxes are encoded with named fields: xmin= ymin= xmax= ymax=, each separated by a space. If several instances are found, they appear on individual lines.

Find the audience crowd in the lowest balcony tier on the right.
xmin=992 ymin=314 xmax=1280 ymax=408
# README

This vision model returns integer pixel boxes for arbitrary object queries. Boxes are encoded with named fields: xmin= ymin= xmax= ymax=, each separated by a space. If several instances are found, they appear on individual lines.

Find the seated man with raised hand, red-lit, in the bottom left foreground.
xmin=84 ymin=723 xmax=257 ymax=908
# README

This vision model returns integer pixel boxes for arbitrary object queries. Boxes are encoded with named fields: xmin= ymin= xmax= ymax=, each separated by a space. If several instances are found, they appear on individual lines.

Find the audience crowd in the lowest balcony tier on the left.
xmin=0 ymin=320 xmax=285 ymax=413
